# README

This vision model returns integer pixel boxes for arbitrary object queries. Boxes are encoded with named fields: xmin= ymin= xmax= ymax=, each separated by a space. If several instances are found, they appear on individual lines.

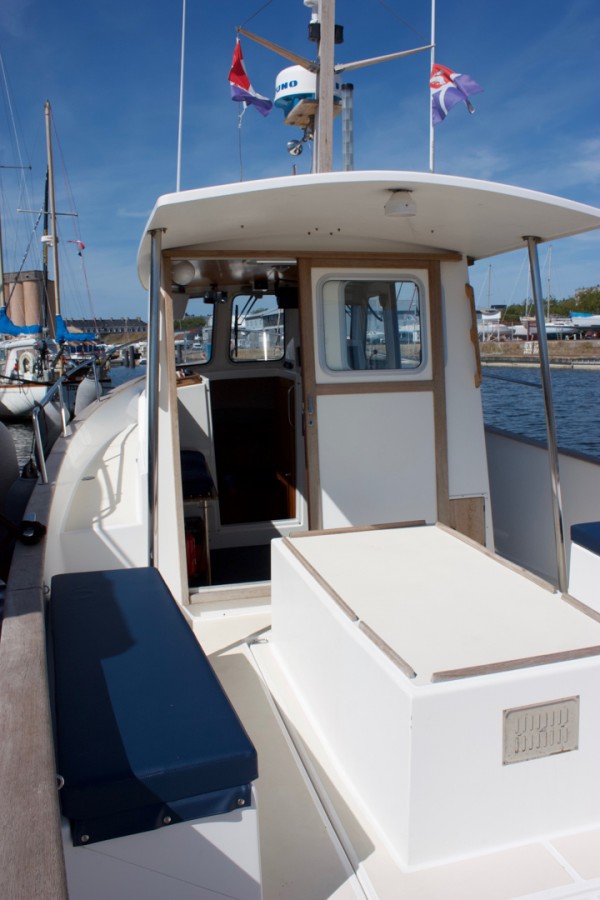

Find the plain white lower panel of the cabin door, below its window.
xmin=316 ymin=391 xmax=437 ymax=528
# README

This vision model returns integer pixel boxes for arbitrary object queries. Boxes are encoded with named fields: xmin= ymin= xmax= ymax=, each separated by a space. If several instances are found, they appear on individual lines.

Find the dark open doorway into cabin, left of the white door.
xmin=172 ymin=285 xmax=308 ymax=592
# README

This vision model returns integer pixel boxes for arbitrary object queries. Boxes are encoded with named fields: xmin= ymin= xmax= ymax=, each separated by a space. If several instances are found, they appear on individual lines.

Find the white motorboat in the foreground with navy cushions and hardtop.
xmin=0 ymin=7 xmax=600 ymax=900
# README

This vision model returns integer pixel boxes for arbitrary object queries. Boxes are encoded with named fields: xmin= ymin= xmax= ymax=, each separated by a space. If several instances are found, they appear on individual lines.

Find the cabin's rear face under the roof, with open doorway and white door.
xmin=158 ymin=248 xmax=492 ymax=593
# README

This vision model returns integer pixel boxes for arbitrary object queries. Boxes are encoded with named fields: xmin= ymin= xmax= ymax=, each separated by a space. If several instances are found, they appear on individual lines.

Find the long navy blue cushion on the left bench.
xmin=50 ymin=568 xmax=258 ymax=840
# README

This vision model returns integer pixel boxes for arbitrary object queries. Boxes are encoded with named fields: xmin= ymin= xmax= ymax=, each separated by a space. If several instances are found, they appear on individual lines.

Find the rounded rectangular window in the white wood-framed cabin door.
xmin=321 ymin=278 xmax=423 ymax=372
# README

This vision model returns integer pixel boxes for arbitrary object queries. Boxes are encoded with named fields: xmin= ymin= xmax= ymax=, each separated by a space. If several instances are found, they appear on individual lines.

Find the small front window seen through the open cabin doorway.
xmin=229 ymin=293 xmax=285 ymax=363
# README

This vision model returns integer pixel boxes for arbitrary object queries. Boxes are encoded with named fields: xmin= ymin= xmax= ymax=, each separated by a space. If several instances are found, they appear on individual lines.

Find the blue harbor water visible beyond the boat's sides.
xmin=4 ymin=366 xmax=600 ymax=464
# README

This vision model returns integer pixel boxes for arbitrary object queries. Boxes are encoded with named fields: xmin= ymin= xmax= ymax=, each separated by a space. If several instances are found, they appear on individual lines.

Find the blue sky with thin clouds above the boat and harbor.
xmin=0 ymin=0 xmax=600 ymax=319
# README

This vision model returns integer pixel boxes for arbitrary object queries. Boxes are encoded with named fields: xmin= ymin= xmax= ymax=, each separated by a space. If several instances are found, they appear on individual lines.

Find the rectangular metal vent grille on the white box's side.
xmin=502 ymin=697 xmax=579 ymax=765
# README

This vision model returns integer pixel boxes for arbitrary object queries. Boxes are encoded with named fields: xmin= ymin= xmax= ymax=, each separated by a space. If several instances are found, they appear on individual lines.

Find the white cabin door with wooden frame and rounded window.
xmin=300 ymin=258 xmax=449 ymax=529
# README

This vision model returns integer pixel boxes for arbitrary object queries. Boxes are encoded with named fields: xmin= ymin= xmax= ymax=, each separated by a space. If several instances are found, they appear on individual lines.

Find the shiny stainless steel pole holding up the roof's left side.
xmin=146 ymin=229 xmax=162 ymax=566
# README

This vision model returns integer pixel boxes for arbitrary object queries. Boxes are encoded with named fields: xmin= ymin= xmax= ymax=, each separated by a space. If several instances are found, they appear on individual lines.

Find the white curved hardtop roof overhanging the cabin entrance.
xmin=138 ymin=171 xmax=600 ymax=285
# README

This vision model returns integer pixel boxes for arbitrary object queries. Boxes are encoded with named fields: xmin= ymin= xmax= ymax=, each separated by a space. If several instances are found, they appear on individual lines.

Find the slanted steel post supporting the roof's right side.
xmin=523 ymin=236 xmax=567 ymax=593
